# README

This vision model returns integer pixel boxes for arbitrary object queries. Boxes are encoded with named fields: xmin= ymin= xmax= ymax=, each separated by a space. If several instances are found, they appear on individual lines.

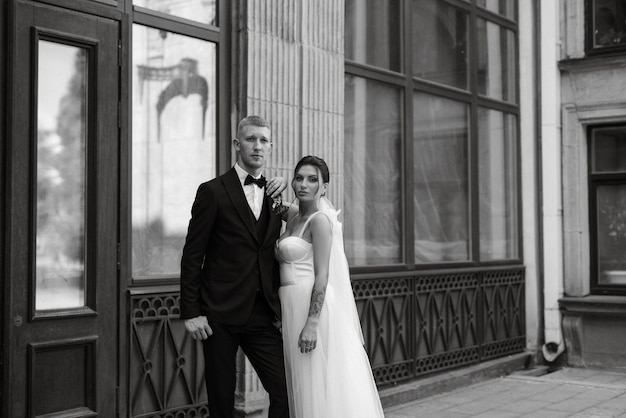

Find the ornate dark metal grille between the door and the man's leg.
xmin=129 ymin=293 xmax=209 ymax=418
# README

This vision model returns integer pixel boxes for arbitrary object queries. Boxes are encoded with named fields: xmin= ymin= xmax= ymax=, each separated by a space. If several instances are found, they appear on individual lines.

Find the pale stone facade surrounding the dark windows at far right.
xmin=556 ymin=0 xmax=626 ymax=367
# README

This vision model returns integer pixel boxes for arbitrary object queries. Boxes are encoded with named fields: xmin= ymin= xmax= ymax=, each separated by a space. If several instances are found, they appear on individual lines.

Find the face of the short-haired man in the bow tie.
xmin=233 ymin=125 xmax=272 ymax=174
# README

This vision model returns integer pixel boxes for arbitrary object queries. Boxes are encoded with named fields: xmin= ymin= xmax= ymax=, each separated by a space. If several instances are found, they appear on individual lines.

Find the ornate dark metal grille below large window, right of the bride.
xmin=353 ymin=267 xmax=526 ymax=386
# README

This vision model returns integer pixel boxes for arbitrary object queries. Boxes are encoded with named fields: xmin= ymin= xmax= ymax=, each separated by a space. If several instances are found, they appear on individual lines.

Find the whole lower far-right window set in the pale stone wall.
xmin=589 ymin=126 xmax=626 ymax=294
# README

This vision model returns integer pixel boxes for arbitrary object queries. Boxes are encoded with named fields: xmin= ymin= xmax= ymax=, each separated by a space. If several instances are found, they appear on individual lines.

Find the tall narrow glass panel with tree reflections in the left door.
xmin=35 ymin=40 xmax=88 ymax=310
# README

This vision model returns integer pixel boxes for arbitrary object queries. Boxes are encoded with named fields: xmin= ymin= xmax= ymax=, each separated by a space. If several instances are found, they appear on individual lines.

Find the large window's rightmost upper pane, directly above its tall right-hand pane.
xmin=477 ymin=19 xmax=517 ymax=102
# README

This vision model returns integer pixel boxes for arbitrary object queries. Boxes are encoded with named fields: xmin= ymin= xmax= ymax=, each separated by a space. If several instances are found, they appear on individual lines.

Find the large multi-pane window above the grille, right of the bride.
xmin=344 ymin=0 xmax=521 ymax=268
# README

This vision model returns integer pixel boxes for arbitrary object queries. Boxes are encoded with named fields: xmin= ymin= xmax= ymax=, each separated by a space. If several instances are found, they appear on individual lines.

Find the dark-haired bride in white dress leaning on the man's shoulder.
xmin=276 ymin=156 xmax=384 ymax=418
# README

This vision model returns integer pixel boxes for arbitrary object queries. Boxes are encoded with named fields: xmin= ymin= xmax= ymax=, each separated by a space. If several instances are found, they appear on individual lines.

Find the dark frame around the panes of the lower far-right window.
xmin=587 ymin=123 xmax=626 ymax=295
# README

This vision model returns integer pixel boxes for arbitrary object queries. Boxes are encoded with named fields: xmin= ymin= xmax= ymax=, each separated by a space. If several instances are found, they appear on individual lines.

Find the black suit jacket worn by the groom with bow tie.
xmin=180 ymin=168 xmax=281 ymax=325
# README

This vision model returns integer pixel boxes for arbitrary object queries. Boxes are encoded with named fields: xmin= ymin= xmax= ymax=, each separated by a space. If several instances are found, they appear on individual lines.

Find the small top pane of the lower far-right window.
xmin=592 ymin=126 xmax=626 ymax=173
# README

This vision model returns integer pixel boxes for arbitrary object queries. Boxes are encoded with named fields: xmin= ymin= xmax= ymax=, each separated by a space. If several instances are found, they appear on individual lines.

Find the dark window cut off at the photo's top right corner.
xmin=585 ymin=0 xmax=626 ymax=54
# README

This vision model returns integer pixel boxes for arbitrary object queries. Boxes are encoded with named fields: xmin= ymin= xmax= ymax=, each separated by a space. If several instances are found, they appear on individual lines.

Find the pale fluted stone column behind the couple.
xmin=232 ymin=0 xmax=344 ymax=417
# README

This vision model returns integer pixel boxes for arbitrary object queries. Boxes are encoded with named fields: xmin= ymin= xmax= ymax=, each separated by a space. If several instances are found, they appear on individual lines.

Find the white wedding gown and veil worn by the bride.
xmin=276 ymin=210 xmax=384 ymax=418
